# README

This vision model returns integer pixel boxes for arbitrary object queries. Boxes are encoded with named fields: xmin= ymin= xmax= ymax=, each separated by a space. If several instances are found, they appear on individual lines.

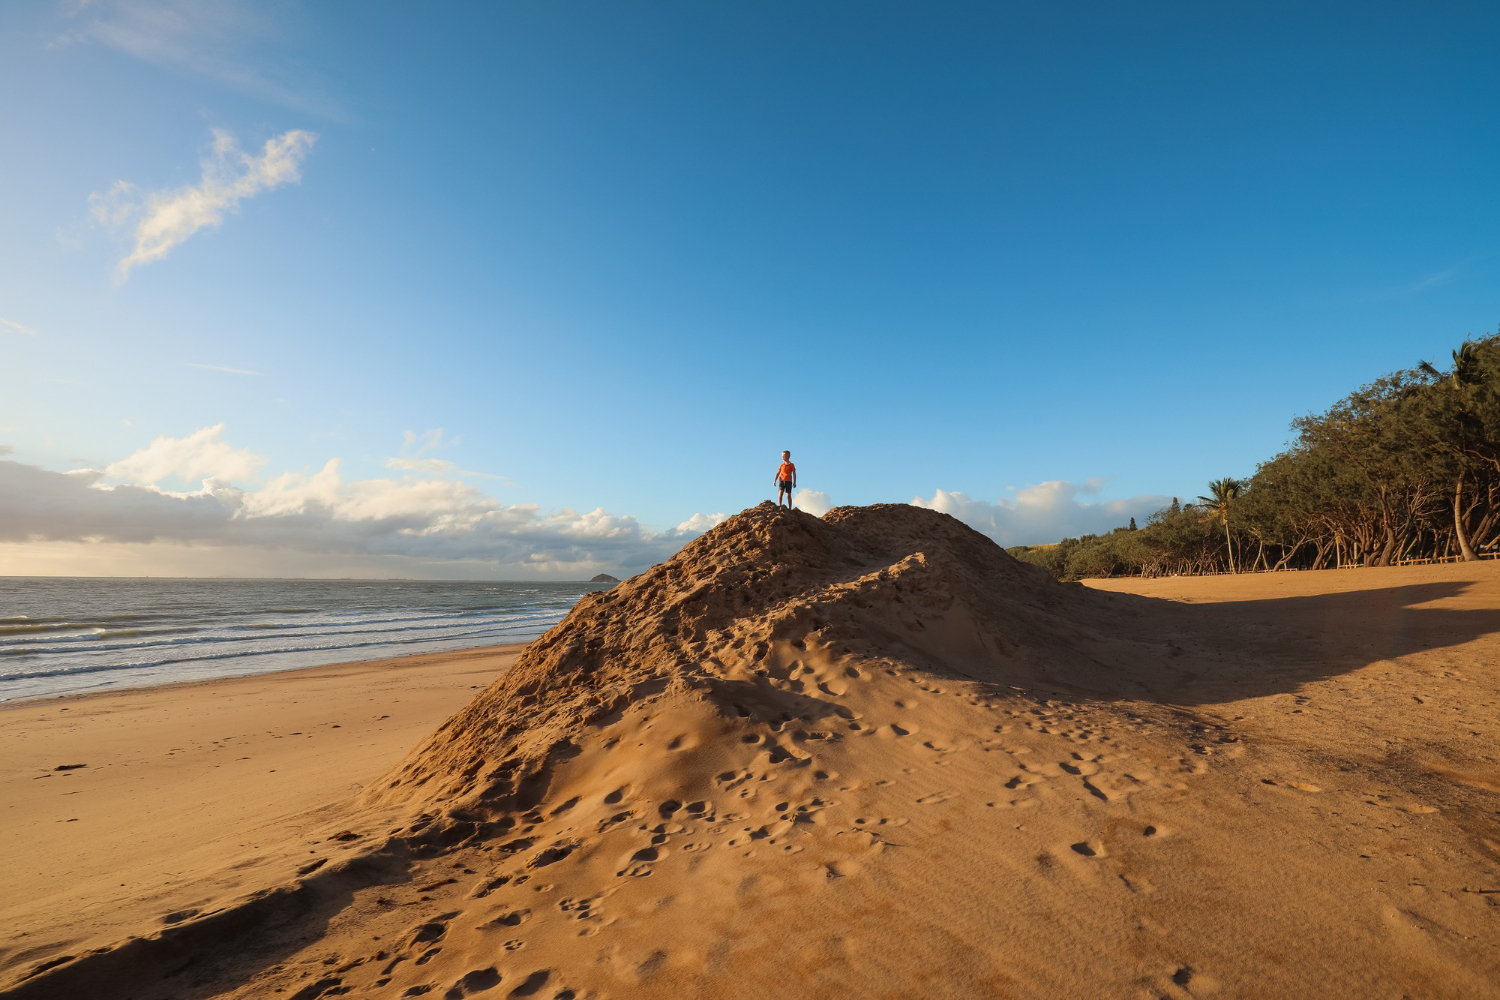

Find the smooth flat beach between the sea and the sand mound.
xmin=0 ymin=645 xmax=522 ymax=995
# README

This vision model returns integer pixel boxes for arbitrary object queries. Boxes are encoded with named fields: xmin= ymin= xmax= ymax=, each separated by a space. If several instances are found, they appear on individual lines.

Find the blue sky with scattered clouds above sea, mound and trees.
xmin=0 ymin=0 xmax=1500 ymax=579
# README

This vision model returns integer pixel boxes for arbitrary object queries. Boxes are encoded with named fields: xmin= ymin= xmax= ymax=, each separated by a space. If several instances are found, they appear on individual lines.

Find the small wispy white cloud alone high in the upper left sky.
xmin=89 ymin=129 xmax=318 ymax=279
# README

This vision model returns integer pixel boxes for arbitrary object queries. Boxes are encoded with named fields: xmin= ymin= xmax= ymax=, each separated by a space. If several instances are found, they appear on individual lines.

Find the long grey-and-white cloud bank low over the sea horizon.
xmin=0 ymin=424 xmax=725 ymax=579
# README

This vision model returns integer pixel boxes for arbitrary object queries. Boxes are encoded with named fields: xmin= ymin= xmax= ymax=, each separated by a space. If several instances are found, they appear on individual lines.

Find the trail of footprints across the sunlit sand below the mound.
xmin=255 ymin=653 xmax=1242 ymax=1000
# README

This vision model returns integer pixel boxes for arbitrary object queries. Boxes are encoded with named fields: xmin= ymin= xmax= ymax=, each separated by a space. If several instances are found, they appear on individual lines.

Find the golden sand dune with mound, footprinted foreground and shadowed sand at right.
xmin=0 ymin=504 xmax=1500 ymax=1000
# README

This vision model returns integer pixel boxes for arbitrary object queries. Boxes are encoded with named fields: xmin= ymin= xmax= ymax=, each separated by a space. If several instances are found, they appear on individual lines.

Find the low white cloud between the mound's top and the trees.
xmin=912 ymin=478 xmax=1170 ymax=546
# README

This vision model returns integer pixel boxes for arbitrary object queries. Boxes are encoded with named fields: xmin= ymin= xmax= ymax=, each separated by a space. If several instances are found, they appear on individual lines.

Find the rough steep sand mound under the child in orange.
xmin=374 ymin=502 xmax=1121 ymax=844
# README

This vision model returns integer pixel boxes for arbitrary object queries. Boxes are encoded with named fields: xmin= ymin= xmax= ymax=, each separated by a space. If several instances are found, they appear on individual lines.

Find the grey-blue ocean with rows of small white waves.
xmin=0 ymin=577 xmax=608 ymax=702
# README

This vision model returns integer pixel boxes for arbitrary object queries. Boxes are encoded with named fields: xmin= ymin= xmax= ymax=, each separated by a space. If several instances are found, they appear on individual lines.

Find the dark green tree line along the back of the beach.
xmin=1008 ymin=330 xmax=1500 ymax=580
